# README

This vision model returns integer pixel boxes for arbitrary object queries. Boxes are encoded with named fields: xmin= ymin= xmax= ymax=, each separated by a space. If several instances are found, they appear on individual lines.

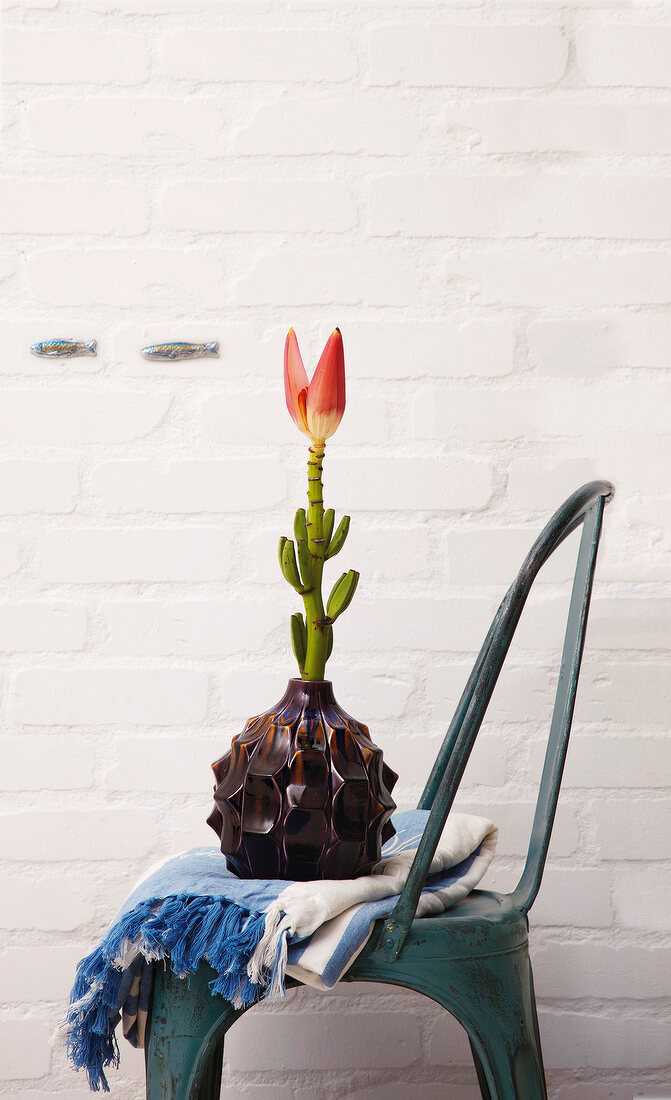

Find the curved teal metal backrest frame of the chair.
xmin=376 ymin=481 xmax=614 ymax=959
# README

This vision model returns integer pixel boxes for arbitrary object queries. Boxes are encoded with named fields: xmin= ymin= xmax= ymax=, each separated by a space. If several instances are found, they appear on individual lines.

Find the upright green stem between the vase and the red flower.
xmin=301 ymin=440 xmax=329 ymax=680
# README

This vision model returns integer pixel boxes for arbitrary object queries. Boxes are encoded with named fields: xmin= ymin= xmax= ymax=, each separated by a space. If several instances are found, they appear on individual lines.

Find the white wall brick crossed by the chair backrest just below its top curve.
xmin=440 ymin=527 xmax=575 ymax=585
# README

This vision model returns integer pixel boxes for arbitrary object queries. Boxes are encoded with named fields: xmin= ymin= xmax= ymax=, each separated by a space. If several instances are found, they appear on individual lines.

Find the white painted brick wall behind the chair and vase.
xmin=0 ymin=0 xmax=671 ymax=1100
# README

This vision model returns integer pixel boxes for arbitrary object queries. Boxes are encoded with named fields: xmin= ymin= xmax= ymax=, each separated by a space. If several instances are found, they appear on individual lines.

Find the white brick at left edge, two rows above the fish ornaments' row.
xmin=0 ymin=177 xmax=149 ymax=237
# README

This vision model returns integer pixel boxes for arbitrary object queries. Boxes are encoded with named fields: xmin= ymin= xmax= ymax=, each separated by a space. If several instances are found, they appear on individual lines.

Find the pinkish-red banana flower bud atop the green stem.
xmin=284 ymin=329 xmax=344 ymax=442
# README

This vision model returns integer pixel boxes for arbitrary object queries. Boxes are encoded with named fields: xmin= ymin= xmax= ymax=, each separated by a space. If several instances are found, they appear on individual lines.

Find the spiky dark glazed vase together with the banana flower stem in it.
xmin=208 ymin=329 xmax=398 ymax=880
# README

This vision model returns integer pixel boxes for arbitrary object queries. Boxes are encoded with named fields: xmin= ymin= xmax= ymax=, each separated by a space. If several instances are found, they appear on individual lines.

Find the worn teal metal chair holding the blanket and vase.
xmin=146 ymin=482 xmax=614 ymax=1100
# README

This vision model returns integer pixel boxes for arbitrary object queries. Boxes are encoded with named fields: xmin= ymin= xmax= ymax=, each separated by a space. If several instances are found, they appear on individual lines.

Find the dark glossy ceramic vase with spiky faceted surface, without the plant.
xmin=208 ymin=680 xmax=398 ymax=881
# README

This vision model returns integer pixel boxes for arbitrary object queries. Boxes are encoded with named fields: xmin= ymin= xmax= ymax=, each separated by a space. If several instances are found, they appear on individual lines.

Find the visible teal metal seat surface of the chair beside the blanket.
xmin=342 ymin=890 xmax=528 ymax=981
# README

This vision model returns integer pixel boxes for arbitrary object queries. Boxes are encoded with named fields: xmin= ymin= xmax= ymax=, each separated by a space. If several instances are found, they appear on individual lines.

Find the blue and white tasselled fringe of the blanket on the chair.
xmin=63 ymin=897 xmax=279 ymax=1092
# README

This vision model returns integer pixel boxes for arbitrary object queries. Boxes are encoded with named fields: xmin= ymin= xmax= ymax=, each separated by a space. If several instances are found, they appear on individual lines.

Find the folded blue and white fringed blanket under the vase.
xmin=64 ymin=810 xmax=498 ymax=1092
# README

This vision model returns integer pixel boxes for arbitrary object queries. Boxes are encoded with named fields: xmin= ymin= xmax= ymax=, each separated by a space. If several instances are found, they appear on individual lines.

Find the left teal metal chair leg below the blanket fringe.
xmin=145 ymin=964 xmax=244 ymax=1100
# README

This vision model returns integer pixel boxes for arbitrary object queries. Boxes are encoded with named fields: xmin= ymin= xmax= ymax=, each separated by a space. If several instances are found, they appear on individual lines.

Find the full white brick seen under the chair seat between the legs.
xmin=226 ymin=1012 xmax=421 ymax=1073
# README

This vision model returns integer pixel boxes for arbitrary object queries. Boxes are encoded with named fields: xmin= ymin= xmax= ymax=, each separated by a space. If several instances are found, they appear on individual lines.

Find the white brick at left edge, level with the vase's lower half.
xmin=0 ymin=806 xmax=156 ymax=861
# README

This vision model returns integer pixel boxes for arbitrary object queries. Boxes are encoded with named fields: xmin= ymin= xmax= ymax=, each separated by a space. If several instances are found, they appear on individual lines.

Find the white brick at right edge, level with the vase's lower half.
xmin=590 ymin=800 xmax=671 ymax=859
